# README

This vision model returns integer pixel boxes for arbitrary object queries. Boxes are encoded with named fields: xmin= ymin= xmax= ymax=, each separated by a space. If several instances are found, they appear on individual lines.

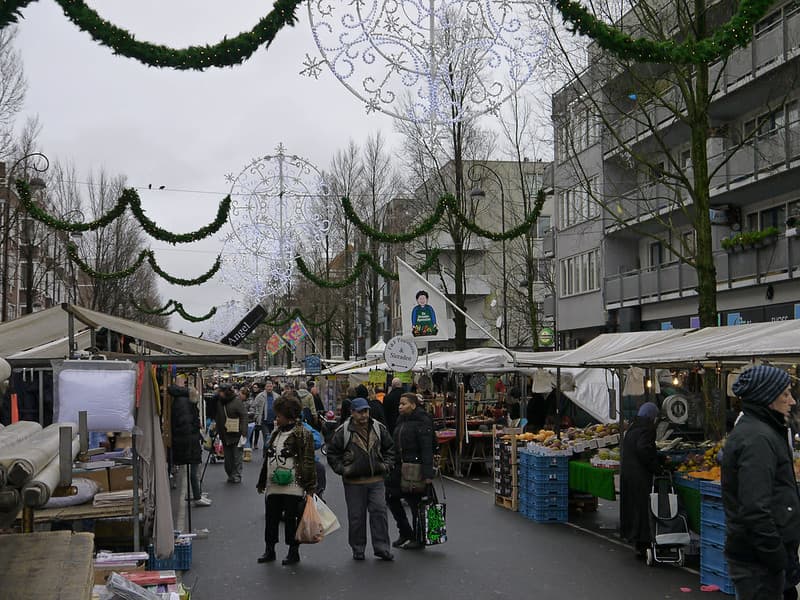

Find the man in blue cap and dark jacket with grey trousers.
xmin=328 ymin=398 xmax=394 ymax=560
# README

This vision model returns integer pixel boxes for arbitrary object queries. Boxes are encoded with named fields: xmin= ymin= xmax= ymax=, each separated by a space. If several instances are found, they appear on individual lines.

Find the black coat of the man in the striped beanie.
xmin=722 ymin=404 xmax=800 ymax=572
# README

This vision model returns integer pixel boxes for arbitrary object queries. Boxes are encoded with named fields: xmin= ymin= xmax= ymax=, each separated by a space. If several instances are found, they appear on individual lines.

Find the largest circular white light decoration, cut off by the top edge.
xmin=300 ymin=0 xmax=549 ymax=126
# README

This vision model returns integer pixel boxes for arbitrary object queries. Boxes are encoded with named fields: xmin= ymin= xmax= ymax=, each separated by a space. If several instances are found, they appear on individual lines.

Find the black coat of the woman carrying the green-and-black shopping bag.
xmin=386 ymin=408 xmax=439 ymax=491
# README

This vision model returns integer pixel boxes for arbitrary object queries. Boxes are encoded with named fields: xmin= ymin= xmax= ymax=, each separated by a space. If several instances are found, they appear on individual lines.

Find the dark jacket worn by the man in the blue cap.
xmin=328 ymin=418 xmax=394 ymax=483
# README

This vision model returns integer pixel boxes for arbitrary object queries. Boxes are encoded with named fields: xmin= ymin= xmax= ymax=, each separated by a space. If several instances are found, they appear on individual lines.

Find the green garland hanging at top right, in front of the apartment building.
xmin=553 ymin=0 xmax=773 ymax=64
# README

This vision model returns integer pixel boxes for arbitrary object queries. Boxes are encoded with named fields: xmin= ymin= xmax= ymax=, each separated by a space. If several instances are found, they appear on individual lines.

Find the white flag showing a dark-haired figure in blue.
xmin=397 ymin=259 xmax=453 ymax=341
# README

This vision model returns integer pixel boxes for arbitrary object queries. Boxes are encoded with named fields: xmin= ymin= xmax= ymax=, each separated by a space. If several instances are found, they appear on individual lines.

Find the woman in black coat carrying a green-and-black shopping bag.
xmin=386 ymin=394 xmax=439 ymax=550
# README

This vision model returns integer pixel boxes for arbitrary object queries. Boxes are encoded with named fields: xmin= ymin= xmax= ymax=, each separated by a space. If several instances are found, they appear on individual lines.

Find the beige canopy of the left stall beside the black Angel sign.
xmin=0 ymin=304 xmax=253 ymax=367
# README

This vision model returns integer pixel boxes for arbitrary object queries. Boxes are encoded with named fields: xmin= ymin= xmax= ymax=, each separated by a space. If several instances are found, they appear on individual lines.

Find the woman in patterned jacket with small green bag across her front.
xmin=256 ymin=392 xmax=317 ymax=565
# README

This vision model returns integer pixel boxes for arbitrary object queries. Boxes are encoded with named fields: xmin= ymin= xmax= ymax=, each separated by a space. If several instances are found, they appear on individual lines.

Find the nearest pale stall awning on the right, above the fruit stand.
xmin=586 ymin=320 xmax=800 ymax=367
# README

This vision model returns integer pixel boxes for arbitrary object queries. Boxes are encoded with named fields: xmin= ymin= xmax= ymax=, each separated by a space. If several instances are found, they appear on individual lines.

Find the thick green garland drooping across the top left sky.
xmin=0 ymin=0 xmax=302 ymax=71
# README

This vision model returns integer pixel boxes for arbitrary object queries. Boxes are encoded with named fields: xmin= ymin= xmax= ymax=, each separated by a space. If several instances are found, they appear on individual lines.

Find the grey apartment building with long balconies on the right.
xmin=545 ymin=2 xmax=800 ymax=348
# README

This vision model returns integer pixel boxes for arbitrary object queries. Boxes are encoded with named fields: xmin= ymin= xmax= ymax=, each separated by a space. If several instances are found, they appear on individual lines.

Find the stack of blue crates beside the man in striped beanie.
xmin=700 ymin=481 xmax=734 ymax=594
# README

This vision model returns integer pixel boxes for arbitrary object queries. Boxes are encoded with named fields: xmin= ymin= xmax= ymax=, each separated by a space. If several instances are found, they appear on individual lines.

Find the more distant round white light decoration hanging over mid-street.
xmin=222 ymin=144 xmax=334 ymax=302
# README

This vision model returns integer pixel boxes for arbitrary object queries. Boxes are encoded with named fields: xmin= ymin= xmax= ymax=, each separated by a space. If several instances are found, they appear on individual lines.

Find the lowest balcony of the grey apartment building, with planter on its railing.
xmin=604 ymin=237 xmax=800 ymax=310
